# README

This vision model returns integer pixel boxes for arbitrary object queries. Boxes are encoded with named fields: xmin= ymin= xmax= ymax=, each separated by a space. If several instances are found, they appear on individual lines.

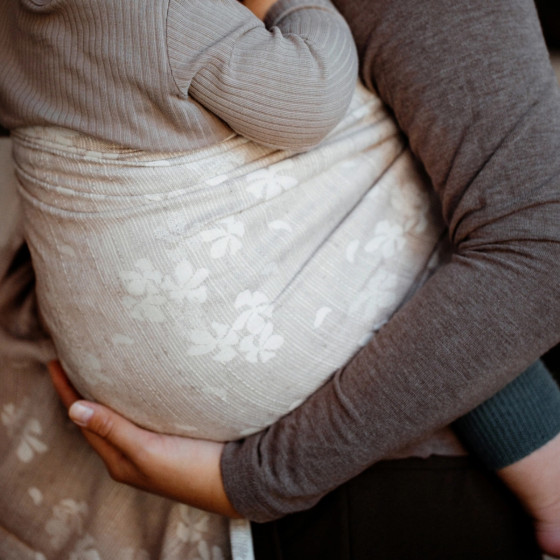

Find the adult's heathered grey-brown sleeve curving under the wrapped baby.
xmin=221 ymin=0 xmax=560 ymax=521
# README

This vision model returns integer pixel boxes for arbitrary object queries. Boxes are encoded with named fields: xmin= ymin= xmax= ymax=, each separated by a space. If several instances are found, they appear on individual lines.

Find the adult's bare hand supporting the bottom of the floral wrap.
xmin=48 ymin=362 xmax=240 ymax=517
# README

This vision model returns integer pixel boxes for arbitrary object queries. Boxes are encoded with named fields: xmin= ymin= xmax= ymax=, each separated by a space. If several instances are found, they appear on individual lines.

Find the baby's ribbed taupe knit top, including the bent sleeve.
xmin=0 ymin=0 xmax=357 ymax=151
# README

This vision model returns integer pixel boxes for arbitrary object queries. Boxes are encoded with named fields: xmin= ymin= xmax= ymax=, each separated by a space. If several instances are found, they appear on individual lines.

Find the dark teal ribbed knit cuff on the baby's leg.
xmin=453 ymin=360 xmax=560 ymax=469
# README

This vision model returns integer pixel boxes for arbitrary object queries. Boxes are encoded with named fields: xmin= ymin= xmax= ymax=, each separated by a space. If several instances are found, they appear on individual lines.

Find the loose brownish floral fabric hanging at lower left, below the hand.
xmin=0 ymin=138 xmax=231 ymax=560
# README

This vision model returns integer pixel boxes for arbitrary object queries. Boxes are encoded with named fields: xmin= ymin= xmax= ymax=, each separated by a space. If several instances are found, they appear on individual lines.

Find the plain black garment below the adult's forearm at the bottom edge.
xmin=252 ymin=456 xmax=542 ymax=560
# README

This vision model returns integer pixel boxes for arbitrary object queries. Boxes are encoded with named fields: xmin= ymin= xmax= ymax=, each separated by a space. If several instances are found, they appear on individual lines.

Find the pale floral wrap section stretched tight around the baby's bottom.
xmin=13 ymin=83 xmax=441 ymax=440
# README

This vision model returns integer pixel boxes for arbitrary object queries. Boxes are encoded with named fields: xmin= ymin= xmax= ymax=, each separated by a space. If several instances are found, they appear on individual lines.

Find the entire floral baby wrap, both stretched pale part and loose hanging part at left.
xmin=0 ymin=84 xmax=446 ymax=560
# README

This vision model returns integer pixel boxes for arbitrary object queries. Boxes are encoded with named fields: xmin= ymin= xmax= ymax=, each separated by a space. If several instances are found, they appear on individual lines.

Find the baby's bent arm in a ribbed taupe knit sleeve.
xmin=167 ymin=0 xmax=357 ymax=150
